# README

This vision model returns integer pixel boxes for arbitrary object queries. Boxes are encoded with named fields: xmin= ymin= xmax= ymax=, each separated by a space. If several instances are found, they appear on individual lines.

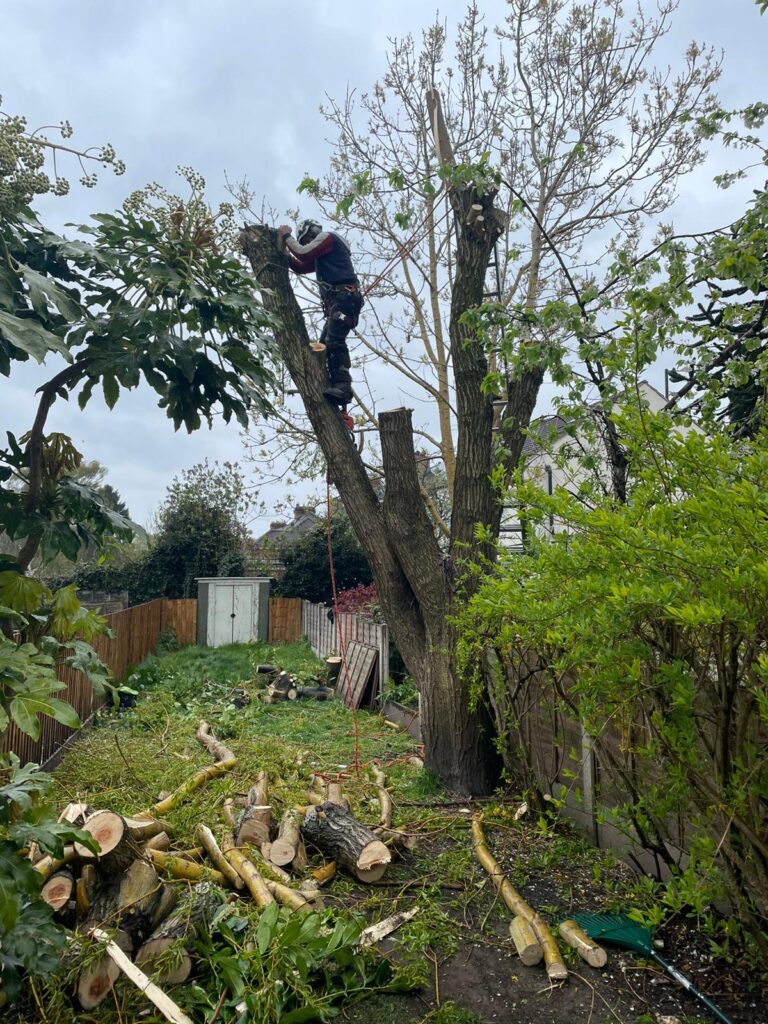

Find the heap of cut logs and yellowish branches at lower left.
xmin=37 ymin=722 xmax=413 ymax=1021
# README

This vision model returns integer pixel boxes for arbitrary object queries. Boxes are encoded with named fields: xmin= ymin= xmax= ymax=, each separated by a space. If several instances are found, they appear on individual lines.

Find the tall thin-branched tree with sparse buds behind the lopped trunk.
xmin=244 ymin=0 xmax=719 ymax=516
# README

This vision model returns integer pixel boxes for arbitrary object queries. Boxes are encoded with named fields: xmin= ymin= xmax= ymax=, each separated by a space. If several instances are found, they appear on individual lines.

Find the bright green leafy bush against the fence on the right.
xmin=463 ymin=412 xmax=768 ymax=951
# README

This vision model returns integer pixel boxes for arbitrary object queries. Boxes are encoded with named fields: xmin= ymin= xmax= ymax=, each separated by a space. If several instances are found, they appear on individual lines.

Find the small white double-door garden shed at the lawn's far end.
xmin=198 ymin=577 xmax=270 ymax=647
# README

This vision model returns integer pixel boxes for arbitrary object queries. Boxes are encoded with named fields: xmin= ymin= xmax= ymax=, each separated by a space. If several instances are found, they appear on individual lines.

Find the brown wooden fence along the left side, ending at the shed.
xmin=0 ymin=598 xmax=198 ymax=764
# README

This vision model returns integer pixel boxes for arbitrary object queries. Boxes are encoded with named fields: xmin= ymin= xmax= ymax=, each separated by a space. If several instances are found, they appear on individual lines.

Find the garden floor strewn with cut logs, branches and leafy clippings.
xmin=14 ymin=645 xmax=758 ymax=1024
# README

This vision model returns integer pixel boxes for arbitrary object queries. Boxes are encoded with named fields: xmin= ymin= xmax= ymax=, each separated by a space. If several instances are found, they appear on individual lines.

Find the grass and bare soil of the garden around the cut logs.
xmin=9 ymin=644 xmax=768 ymax=1024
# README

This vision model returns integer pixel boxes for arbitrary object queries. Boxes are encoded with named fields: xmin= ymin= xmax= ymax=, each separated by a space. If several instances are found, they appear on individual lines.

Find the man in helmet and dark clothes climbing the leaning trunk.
xmin=278 ymin=220 xmax=362 ymax=430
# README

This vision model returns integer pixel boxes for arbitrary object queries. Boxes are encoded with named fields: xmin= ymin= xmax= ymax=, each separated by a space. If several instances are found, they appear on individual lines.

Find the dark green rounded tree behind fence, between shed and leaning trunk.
xmin=274 ymin=509 xmax=373 ymax=604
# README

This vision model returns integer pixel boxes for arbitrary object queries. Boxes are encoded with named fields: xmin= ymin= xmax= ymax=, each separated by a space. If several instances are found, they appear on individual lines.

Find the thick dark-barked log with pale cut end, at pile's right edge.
xmin=301 ymin=803 xmax=391 ymax=881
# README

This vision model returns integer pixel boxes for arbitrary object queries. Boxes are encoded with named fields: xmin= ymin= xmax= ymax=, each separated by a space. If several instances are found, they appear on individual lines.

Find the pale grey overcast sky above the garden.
xmin=0 ymin=0 xmax=768 ymax=532
